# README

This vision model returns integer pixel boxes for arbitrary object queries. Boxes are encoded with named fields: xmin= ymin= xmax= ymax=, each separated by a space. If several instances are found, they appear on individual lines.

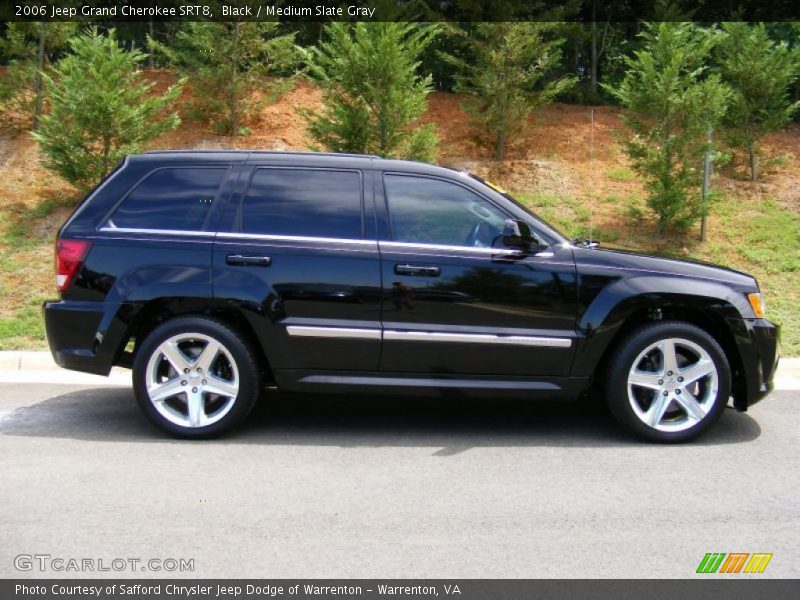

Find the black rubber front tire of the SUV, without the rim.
xmin=605 ymin=322 xmax=731 ymax=443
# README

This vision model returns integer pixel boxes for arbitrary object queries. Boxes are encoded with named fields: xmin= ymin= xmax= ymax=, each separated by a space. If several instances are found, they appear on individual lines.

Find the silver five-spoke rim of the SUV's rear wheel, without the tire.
xmin=146 ymin=333 xmax=239 ymax=428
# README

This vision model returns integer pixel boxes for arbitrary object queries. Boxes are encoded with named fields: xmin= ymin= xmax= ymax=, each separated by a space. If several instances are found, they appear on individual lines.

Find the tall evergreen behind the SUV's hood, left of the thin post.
xmin=606 ymin=22 xmax=730 ymax=231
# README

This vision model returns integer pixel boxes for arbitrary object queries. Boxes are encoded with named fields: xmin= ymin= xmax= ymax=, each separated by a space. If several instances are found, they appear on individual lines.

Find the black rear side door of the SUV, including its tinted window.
xmin=213 ymin=164 xmax=381 ymax=376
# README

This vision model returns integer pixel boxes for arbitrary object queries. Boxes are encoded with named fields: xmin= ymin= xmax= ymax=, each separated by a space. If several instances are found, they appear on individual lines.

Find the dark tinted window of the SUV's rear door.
xmin=242 ymin=169 xmax=361 ymax=239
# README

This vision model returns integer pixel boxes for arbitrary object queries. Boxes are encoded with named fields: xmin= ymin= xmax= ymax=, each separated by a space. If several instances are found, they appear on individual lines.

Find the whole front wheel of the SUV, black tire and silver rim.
xmin=605 ymin=321 xmax=731 ymax=442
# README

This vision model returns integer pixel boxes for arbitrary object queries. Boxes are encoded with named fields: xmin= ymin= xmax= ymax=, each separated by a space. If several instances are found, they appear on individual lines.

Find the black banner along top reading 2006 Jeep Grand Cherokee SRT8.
xmin=0 ymin=0 xmax=800 ymax=23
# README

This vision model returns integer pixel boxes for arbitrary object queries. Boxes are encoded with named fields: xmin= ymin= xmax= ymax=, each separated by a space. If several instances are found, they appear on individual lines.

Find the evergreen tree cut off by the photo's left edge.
xmin=0 ymin=21 xmax=77 ymax=128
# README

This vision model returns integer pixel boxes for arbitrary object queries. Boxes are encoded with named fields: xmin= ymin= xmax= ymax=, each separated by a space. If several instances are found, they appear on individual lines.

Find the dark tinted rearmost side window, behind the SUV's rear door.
xmin=108 ymin=168 xmax=226 ymax=231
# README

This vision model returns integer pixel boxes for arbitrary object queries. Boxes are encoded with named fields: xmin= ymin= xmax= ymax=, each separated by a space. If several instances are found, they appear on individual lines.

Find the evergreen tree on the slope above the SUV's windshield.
xmin=444 ymin=22 xmax=576 ymax=160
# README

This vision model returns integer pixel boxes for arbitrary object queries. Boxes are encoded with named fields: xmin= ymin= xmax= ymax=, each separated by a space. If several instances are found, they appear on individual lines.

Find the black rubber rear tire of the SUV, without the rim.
xmin=133 ymin=317 xmax=259 ymax=438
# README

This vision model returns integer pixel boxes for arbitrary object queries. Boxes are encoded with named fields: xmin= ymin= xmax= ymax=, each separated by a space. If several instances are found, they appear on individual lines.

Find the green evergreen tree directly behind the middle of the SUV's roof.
xmin=304 ymin=22 xmax=438 ymax=160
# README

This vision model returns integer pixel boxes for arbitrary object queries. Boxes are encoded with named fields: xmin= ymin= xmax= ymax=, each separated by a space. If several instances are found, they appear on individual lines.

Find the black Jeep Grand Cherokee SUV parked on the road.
xmin=44 ymin=151 xmax=778 ymax=442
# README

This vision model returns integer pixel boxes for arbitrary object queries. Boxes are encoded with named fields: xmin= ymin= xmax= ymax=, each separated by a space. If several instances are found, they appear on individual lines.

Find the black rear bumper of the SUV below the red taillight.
xmin=42 ymin=300 xmax=126 ymax=375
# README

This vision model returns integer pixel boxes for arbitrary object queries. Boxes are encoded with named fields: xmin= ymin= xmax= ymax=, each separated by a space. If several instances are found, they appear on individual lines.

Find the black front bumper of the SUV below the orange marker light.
xmin=729 ymin=319 xmax=780 ymax=410
